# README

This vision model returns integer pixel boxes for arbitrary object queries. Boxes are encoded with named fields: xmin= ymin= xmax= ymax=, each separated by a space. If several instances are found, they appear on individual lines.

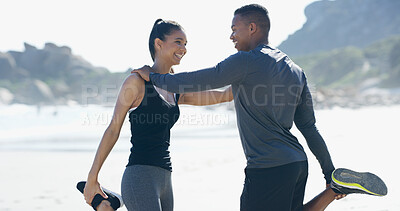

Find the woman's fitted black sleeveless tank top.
xmin=127 ymin=81 xmax=179 ymax=171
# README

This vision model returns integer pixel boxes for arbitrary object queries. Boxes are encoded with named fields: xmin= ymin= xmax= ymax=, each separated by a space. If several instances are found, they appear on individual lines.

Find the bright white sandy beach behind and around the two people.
xmin=0 ymin=106 xmax=400 ymax=211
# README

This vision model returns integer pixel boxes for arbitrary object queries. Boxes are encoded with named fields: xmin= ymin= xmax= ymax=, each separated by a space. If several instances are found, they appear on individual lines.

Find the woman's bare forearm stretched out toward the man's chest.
xmin=178 ymin=86 xmax=233 ymax=106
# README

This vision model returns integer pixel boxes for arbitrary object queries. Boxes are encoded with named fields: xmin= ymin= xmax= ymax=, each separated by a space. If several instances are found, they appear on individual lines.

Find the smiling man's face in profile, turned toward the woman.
xmin=230 ymin=15 xmax=251 ymax=51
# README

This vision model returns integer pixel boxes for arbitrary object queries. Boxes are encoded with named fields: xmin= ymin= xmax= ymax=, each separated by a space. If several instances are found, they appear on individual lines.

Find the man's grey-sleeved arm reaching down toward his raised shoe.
xmin=294 ymin=83 xmax=335 ymax=184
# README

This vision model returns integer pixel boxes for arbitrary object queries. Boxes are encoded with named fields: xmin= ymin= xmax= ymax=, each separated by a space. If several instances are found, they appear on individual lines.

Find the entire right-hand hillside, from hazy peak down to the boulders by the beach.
xmin=278 ymin=0 xmax=400 ymax=107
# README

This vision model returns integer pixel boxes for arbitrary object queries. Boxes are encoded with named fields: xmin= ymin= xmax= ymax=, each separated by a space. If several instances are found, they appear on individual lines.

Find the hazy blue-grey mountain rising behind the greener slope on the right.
xmin=278 ymin=0 xmax=400 ymax=57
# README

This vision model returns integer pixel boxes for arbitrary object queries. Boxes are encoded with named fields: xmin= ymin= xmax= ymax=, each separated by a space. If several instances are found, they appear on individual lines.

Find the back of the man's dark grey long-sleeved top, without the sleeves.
xmin=232 ymin=45 xmax=307 ymax=168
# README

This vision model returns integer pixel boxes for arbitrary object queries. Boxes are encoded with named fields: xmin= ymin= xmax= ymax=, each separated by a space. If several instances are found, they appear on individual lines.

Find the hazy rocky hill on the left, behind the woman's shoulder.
xmin=0 ymin=43 xmax=126 ymax=104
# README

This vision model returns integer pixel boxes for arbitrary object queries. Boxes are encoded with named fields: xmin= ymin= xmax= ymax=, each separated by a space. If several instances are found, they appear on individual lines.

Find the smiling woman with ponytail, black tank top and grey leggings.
xmin=84 ymin=19 xmax=233 ymax=211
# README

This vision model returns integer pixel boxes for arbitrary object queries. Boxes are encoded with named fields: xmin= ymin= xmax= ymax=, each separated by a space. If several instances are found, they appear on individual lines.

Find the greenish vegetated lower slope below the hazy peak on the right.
xmin=293 ymin=36 xmax=400 ymax=88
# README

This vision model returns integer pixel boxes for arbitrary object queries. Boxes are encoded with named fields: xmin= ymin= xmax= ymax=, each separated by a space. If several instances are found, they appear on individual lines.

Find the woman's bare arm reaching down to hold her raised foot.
xmin=84 ymin=74 xmax=144 ymax=204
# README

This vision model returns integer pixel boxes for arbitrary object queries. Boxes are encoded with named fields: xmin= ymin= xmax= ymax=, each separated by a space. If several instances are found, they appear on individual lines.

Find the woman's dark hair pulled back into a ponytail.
xmin=149 ymin=19 xmax=183 ymax=61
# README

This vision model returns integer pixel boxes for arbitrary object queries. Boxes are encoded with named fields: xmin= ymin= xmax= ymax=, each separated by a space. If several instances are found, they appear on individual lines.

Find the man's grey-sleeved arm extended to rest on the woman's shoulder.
xmin=138 ymin=52 xmax=248 ymax=93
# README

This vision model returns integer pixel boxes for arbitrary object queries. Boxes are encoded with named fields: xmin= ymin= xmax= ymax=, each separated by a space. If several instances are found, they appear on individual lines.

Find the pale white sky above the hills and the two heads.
xmin=0 ymin=0 xmax=316 ymax=72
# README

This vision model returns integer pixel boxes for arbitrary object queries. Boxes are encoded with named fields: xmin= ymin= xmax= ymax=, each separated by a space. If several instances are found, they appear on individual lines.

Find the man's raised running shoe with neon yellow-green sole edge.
xmin=331 ymin=168 xmax=387 ymax=196
